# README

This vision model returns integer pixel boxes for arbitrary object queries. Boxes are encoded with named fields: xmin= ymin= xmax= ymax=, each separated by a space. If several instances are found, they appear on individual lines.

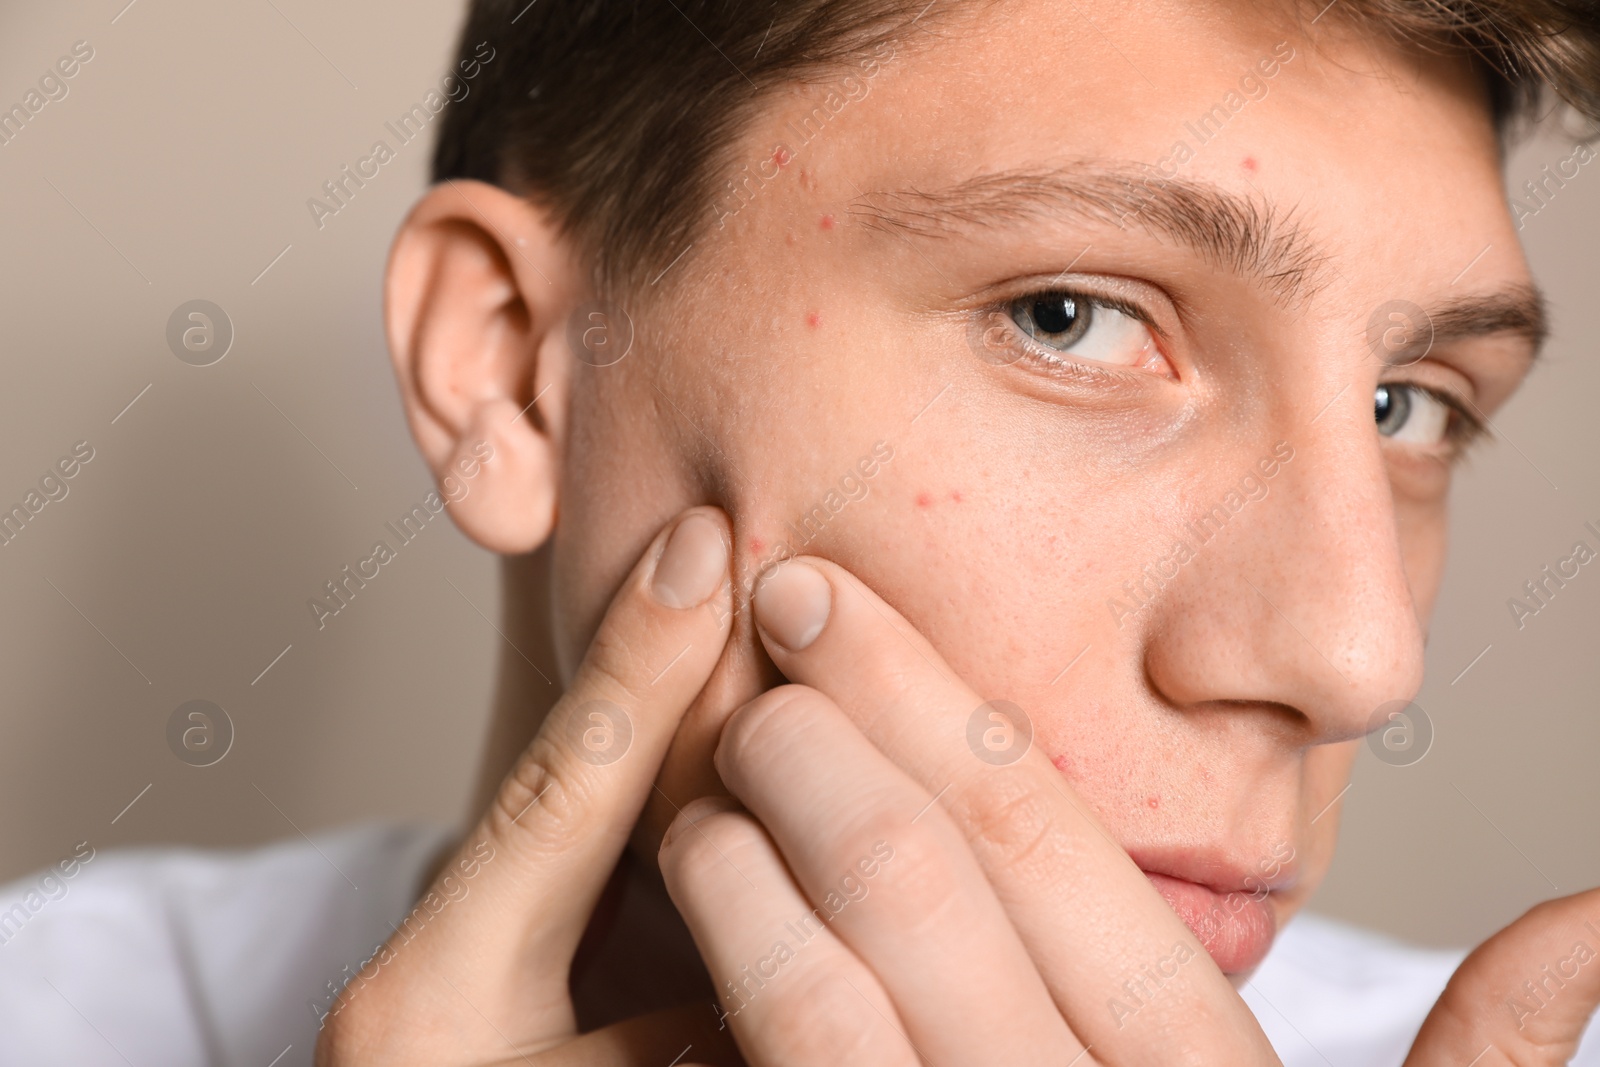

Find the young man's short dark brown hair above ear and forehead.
xmin=434 ymin=0 xmax=1600 ymax=294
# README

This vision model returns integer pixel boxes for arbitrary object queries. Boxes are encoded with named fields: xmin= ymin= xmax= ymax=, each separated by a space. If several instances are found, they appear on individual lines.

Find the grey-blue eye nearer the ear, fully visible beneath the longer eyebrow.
xmin=1006 ymin=290 xmax=1170 ymax=374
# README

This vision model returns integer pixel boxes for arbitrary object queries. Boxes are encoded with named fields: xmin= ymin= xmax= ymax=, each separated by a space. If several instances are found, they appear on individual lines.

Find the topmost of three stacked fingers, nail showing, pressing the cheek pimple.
xmin=755 ymin=557 xmax=1277 ymax=1064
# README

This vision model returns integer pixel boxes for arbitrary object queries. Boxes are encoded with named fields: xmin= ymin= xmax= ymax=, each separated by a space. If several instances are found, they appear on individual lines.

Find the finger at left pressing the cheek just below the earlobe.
xmin=462 ymin=509 xmax=731 ymax=953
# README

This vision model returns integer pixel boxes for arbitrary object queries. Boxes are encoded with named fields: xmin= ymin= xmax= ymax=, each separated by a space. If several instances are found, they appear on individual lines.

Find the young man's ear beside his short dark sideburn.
xmin=384 ymin=181 xmax=579 ymax=555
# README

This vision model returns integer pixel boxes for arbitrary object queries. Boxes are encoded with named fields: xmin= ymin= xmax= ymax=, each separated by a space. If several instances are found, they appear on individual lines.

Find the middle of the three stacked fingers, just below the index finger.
xmin=717 ymin=685 xmax=1091 ymax=1067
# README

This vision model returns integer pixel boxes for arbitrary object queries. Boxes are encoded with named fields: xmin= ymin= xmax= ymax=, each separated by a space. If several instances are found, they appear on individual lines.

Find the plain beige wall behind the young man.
xmin=0 ymin=0 xmax=1600 ymax=944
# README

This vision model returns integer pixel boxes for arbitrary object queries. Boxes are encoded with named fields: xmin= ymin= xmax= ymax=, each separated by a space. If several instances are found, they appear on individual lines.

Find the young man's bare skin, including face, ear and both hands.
xmin=318 ymin=0 xmax=1600 ymax=1065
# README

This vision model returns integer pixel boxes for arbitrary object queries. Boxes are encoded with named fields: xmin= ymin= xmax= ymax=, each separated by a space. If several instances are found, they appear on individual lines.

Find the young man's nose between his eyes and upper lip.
xmin=1146 ymin=398 xmax=1422 ymax=744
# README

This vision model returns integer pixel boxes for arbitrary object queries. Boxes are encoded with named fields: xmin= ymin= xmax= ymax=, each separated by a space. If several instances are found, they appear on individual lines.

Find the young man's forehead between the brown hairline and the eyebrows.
xmin=713 ymin=0 xmax=1526 ymax=308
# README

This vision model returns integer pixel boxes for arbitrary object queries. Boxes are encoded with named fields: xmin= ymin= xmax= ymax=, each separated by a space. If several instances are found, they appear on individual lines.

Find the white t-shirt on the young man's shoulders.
xmin=0 ymin=825 xmax=1600 ymax=1067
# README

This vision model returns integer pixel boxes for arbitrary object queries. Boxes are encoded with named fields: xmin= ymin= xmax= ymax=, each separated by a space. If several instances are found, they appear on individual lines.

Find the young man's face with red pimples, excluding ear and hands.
xmin=537 ymin=0 xmax=1531 ymax=971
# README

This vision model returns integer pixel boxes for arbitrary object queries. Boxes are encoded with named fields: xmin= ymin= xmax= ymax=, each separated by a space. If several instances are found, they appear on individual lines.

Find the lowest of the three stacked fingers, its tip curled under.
xmin=661 ymin=797 xmax=921 ymax=1067
